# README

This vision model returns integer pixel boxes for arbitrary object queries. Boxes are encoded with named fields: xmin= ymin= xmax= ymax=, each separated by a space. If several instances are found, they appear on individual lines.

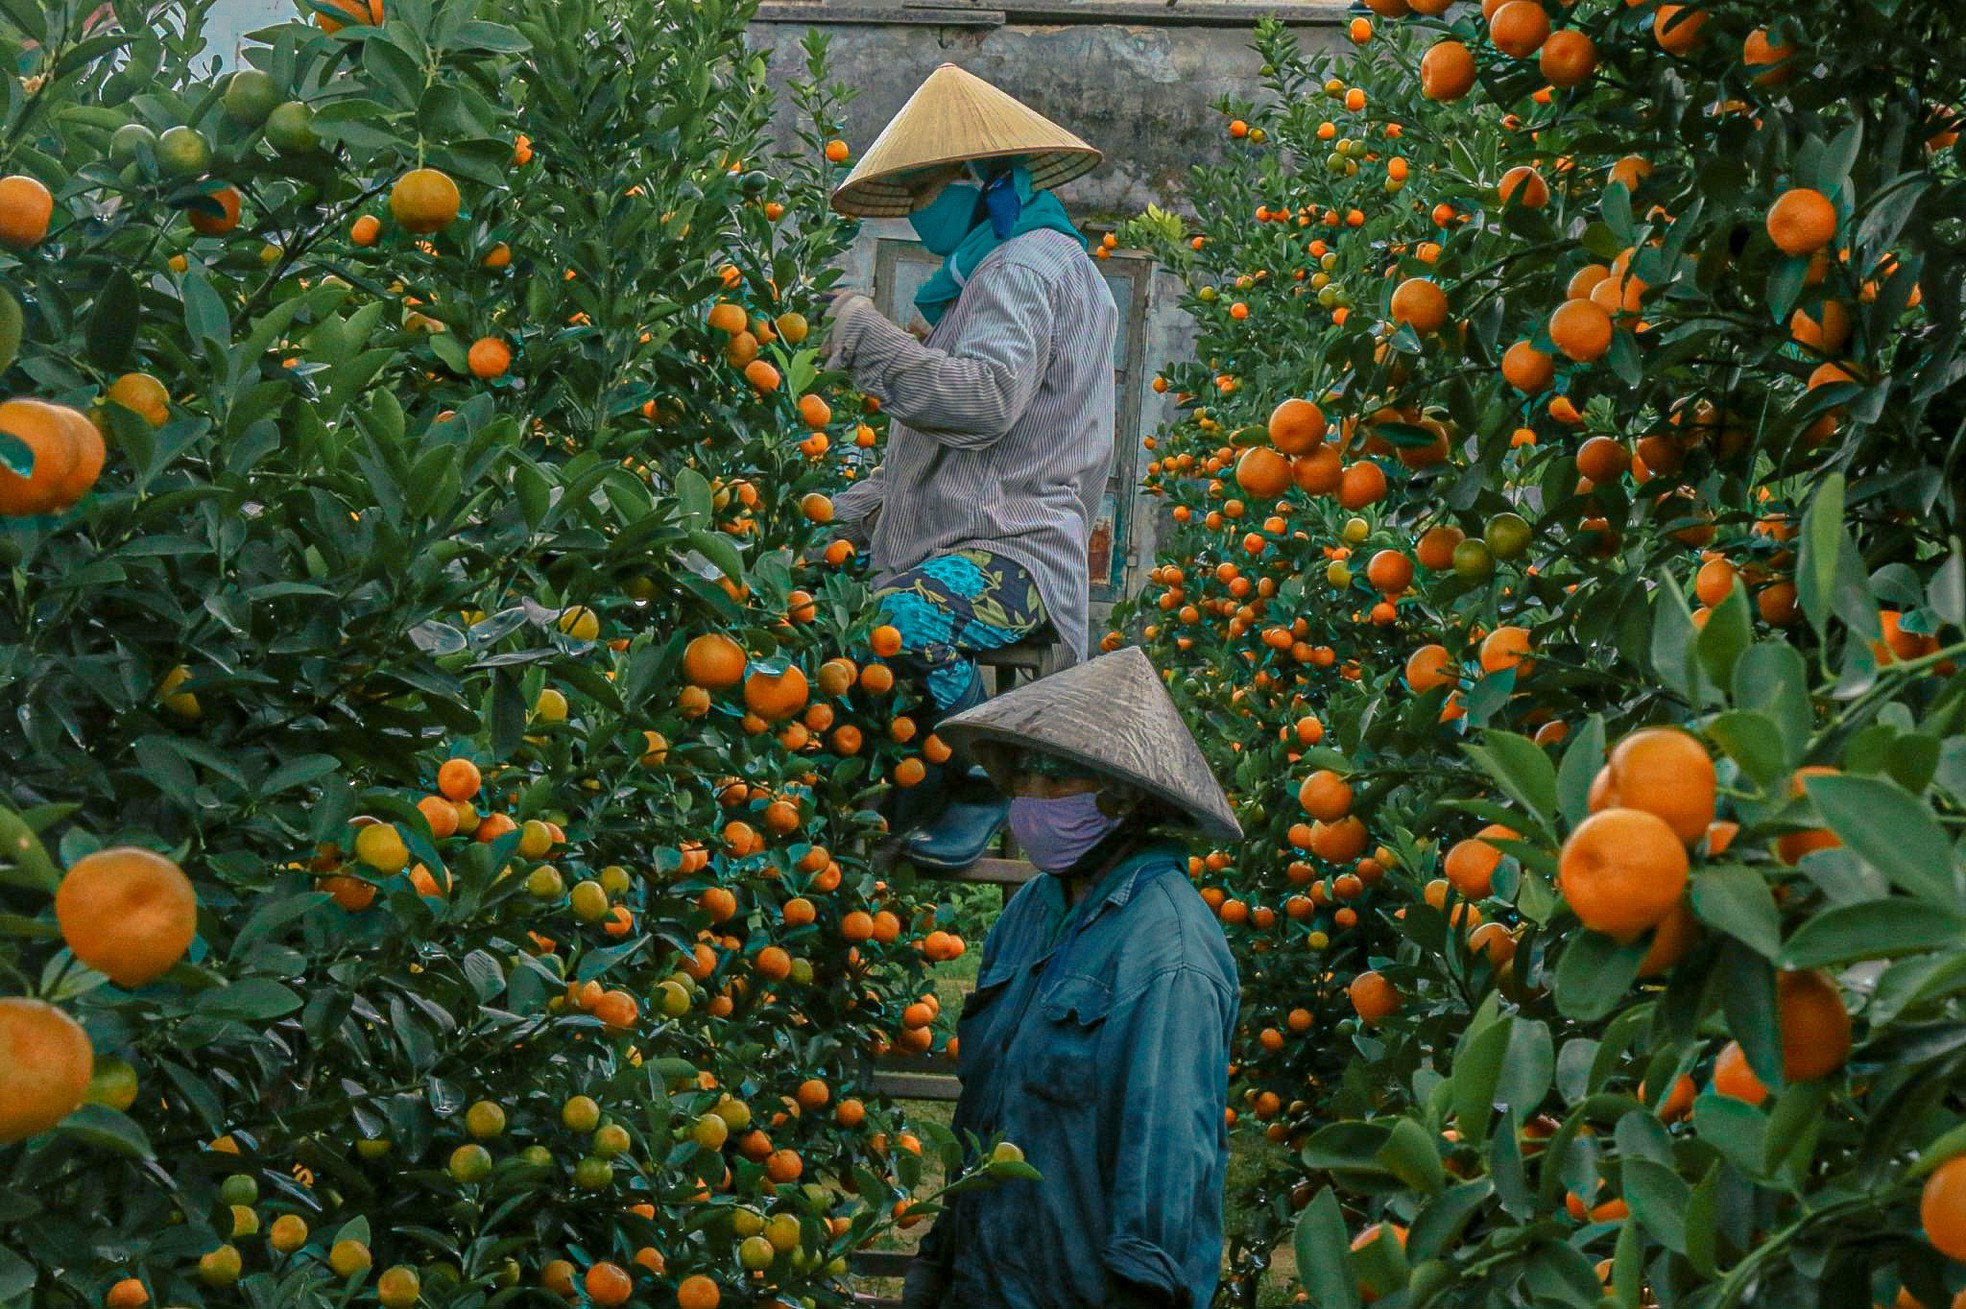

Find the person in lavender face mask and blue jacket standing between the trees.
xmin=900 ymin=647 xmax=1243 ymax=1309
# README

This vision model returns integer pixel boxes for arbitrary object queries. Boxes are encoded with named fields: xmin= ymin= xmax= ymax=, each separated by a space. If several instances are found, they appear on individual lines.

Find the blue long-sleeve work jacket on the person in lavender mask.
xmin=922 ymin=843 xmax=1239 ymax=1309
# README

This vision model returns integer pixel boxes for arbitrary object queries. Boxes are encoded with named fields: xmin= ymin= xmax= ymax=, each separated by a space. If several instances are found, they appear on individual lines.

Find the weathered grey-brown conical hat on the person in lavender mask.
xmin=936 ymin=647 xmax=1243 ymax=841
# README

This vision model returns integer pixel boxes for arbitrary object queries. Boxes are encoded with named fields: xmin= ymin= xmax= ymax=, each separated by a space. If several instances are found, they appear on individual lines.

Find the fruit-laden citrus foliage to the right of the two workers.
xmin=1109 ymin=0 xmax=1966 ymax=1309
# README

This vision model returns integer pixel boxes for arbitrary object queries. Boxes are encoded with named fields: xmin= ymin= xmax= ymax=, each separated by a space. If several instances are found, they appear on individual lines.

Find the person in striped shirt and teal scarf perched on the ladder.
xmin=826 ymin=63 xmax=1119 ymax=869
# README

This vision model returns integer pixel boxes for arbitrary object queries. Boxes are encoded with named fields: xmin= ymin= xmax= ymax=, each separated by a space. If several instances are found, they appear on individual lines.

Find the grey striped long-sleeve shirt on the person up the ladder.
xmin=834 ymin=230 xmax=1119 ymax=658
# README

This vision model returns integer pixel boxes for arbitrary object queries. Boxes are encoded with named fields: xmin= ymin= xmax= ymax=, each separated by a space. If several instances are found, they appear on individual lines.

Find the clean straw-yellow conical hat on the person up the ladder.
xmin=834 ymin=63 xmax=1099 ymax=218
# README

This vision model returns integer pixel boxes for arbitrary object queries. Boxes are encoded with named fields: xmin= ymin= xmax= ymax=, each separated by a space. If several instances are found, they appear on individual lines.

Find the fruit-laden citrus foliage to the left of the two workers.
xmin=0 ymin=0 xmax=1028 ymax=1309
